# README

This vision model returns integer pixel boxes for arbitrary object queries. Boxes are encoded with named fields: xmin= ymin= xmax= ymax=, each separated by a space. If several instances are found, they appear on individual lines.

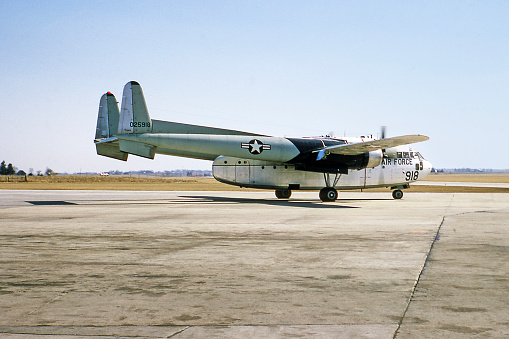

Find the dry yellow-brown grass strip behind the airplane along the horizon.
xmin=0 ymin=173 xmax=509 ymax=193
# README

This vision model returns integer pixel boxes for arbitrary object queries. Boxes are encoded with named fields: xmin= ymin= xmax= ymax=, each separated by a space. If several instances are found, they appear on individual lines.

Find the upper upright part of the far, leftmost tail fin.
xmin=95 ymin=92 xmax=120 ymax=140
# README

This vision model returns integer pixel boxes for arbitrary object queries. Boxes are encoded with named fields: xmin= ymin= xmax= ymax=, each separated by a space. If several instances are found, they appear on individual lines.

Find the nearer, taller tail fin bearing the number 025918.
xmin=118 ymin=81 xmax=152 ymax=134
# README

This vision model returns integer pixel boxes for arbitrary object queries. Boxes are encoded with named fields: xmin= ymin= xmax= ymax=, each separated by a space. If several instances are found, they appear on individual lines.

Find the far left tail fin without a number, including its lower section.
xmin=95 ymin=92 xmax=128 ymax=161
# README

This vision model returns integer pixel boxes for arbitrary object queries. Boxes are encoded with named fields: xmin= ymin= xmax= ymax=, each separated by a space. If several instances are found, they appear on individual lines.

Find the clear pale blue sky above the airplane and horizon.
xmin=0 ymin=1 xmax=509 ymax=172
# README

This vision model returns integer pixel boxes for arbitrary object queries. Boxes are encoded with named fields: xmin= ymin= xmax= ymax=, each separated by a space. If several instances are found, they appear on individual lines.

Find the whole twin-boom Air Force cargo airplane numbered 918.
xmin=94 ymin=81 xmax=432 ymax=202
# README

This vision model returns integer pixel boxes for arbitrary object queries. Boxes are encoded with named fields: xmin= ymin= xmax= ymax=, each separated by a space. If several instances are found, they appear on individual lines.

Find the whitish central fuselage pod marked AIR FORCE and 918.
xmin=212 ymin=146 xmax=432 ymax=190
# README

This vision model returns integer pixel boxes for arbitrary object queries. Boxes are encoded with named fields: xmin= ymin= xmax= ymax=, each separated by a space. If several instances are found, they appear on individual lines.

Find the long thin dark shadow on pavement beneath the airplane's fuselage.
xmin=179 ymin=195 xmax=359 ymax=209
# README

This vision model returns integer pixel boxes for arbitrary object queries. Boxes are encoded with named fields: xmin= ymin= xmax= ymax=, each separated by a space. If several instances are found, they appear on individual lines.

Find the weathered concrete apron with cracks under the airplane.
xmin=0 ymin=190 xmax=509 ymax=338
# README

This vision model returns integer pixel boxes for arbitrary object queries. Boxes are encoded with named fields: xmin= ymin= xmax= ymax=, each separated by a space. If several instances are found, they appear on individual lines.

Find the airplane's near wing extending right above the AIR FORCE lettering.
xmin=317 ymin=134 xmax=429 ymax=160
